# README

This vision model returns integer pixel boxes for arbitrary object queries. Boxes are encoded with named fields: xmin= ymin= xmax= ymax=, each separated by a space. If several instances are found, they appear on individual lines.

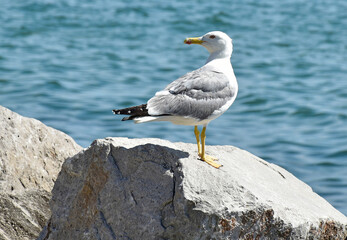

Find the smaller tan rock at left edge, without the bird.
xmin=0 ymin=106 xmax=82 ymax=240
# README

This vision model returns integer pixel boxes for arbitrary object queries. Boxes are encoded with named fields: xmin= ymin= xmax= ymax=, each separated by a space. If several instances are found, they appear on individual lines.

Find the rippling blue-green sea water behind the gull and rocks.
xmin=0 ymin=0 xmax=347 ymax=214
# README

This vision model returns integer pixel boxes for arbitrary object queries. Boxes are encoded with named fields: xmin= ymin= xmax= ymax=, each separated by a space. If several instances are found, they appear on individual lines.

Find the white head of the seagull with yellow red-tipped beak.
xmin=184 ymin=31 xmax=233 ymax=58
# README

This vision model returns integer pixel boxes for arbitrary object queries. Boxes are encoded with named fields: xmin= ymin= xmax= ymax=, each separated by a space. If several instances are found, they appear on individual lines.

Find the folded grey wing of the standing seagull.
xmin=147 ymin=67 xmax=235 ymax=120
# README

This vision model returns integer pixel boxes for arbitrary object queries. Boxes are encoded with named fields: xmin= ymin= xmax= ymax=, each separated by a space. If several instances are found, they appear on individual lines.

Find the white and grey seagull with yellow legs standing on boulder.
xmin=113 ymin=31 xmax=238 ymax=168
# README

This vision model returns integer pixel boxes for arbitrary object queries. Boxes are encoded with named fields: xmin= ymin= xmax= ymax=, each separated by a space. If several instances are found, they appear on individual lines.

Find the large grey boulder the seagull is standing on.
xmin=39 ymin=138 xmax=347 ymax=240
